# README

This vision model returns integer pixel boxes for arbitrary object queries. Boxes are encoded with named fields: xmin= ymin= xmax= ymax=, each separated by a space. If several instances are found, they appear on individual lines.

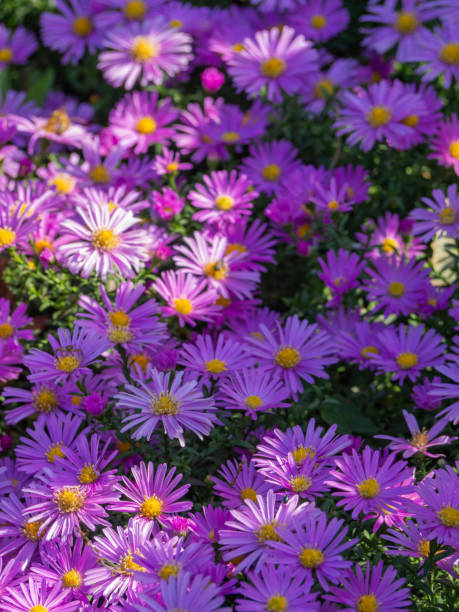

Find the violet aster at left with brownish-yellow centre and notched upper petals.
xmin=24 ymin=327 xmax=109 ymax=383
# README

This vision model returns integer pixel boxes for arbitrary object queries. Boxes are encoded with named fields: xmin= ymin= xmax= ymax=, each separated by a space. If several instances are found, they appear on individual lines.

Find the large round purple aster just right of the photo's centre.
xmin=247 ymin=315 xmax=336 ymax=401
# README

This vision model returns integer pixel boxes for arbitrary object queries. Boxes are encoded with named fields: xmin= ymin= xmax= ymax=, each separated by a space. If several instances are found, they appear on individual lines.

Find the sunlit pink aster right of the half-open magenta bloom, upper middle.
xmin=188 ymin=170 xmax=258 ymax=226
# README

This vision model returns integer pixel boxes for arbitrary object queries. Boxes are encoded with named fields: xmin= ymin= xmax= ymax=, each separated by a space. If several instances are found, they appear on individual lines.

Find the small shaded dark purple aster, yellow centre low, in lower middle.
xmin=211 ymin=460 xmax=272 ymax=508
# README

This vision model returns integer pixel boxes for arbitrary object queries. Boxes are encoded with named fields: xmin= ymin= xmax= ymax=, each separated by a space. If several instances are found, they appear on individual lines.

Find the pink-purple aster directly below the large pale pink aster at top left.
xmin=109 ymin=91 xmax=179 ymax=153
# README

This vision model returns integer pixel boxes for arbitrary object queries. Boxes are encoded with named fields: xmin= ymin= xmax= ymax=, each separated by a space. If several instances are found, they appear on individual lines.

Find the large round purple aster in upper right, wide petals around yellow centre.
xmin=334 ymin=81 xmax=423 ymax=151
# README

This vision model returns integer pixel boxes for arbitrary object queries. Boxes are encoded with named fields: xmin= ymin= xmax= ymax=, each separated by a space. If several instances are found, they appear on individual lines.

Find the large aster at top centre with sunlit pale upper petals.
xmin=228 ymin=26 xmax=317 ymax=102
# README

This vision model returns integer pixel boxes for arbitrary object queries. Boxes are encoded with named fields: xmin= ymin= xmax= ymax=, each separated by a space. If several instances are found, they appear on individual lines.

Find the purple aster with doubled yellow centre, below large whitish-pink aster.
xmin=76 ymin=281 xmax=166 ymax=352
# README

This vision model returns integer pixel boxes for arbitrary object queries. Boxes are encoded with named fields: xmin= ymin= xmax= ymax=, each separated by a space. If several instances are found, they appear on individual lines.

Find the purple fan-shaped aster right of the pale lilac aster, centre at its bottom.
xmin=215 ymin=368 xmax=290 ymax=420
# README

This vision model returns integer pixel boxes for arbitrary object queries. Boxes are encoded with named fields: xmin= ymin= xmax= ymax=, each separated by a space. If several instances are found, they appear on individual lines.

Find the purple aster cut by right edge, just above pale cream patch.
xmin=409 ymin=185 xmax=459 ymax=242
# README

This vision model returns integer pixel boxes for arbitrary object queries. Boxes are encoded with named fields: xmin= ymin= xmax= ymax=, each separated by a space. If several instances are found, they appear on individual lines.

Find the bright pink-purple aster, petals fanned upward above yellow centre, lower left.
xmin=109 ymin=461 xmax=193 ymax=521
